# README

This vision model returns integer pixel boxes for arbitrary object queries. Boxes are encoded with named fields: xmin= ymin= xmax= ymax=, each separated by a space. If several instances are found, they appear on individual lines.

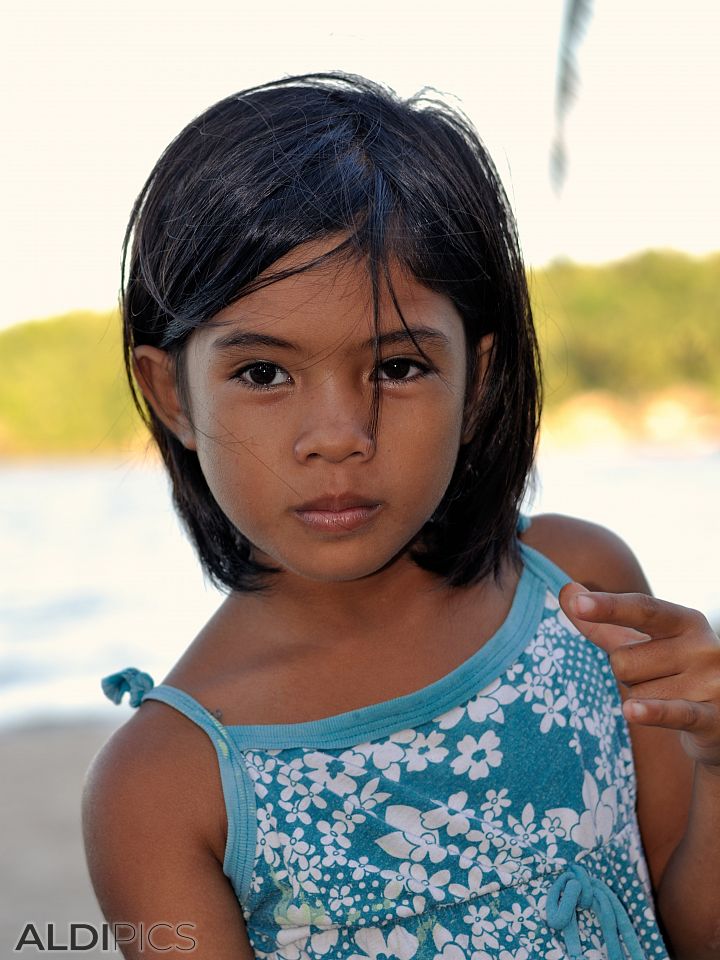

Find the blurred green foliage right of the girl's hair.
xmin=530 ymin=252 xmax=720 ymax=407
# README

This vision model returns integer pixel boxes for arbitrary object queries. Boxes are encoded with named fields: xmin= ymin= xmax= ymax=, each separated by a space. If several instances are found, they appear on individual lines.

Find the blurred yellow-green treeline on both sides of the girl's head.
xmin=0 ymin=252 xmax=720 ymax=456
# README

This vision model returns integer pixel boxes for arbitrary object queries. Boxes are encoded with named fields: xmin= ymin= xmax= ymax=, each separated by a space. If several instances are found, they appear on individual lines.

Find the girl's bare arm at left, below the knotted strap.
xmin=83 ymin=703 xmax=255 ymax=960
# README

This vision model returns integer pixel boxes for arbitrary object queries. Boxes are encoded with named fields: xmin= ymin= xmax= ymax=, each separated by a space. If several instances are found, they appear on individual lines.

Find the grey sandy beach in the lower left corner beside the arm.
xmin=0 ymin=720 xmax=120 ymax=958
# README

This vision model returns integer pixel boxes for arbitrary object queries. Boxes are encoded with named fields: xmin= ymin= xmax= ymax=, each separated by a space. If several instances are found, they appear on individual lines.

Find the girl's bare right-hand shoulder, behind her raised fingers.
xmin=520 ymin=513 xmax=650 ymax=593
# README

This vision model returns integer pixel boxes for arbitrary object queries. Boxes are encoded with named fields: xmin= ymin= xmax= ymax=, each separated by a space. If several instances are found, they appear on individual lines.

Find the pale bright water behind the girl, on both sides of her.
xmin=0 ymin=451 xmax=720 ymax=724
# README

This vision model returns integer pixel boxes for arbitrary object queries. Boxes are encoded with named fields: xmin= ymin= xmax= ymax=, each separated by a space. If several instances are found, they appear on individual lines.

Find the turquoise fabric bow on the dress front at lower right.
xmin=547 ymin=863 xmax=645 ymax=960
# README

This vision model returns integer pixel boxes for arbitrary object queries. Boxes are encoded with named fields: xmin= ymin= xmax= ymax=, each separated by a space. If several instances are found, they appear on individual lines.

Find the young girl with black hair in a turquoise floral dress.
xmin=84 ymin=74 xmax=720 ymax=960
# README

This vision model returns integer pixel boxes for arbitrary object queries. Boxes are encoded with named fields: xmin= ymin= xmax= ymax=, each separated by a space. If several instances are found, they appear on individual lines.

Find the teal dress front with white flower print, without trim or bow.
xmin=225 ymin=576 xmax=667 ymax=960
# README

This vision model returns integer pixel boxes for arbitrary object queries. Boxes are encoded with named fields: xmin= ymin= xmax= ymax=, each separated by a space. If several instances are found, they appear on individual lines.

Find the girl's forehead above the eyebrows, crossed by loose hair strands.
xmin=197 ymin=240 xmax=464 ymax=350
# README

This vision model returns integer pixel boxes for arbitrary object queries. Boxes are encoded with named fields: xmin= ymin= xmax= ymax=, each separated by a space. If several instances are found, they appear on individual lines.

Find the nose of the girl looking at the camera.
xmin=293 ymin=376 xmax=374 ymax=463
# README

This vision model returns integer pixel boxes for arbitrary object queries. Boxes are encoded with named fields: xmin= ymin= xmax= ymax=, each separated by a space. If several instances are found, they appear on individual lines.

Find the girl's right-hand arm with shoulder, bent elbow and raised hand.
xmin=526 ymin=517 xmax=720 ymax=960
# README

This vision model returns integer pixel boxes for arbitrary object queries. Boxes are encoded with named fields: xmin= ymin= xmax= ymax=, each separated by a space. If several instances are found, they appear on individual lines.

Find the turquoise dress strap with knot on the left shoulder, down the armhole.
xmin=102 ymin=667 xmax=257 ymax=904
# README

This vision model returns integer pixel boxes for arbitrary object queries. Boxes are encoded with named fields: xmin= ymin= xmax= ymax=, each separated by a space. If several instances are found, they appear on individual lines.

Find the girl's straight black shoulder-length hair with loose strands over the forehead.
xmin=121 ymin=72 xmax=541 ymax=592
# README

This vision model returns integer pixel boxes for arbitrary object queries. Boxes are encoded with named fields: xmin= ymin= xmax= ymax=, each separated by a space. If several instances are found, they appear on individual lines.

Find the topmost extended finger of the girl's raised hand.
xmin=568 ymin=590 xmax=710 ymax=639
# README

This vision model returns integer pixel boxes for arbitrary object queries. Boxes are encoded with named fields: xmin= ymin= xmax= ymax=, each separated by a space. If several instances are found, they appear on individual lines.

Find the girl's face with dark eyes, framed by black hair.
xmin=136 ymin=242 xmax=489 ymax=582
